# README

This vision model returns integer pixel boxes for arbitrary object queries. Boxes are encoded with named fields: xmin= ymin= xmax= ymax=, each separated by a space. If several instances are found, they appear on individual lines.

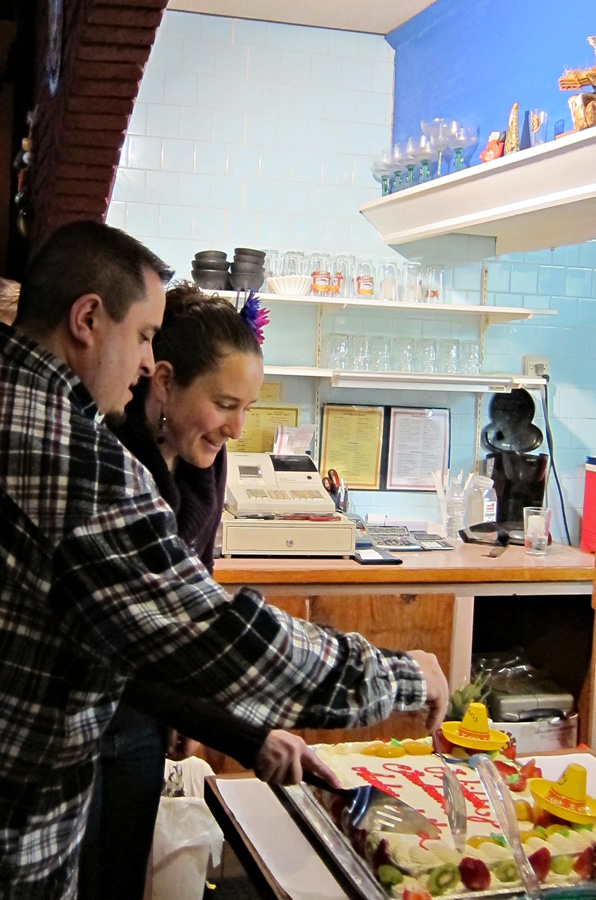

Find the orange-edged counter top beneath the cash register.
xmin=215 ymin=543 xmax=594 ymax=585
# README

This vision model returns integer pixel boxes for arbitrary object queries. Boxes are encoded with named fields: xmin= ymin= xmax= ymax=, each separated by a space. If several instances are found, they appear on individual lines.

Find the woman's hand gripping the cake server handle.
xmin=255 ymin=731 xmax=341 ymax=788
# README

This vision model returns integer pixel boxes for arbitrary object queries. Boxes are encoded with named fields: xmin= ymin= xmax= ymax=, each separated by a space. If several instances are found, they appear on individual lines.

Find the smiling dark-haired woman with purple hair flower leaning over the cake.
xmin=79 ymin=283 xmax=339 ymax=900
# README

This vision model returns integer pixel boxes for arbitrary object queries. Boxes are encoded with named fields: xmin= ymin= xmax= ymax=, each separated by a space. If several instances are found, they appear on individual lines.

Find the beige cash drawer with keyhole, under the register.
xmin=221 ymin=513 xmax=355 ymax=557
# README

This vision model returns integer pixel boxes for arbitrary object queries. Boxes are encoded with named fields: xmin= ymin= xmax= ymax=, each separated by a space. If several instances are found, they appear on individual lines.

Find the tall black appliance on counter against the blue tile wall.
xmin=481 ymin=388 xmax=548 ymax=534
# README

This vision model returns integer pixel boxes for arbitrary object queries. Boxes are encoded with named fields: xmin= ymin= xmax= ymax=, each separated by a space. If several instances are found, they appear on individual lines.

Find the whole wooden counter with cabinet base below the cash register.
xmin=209 ymin=544 xmax=596 ymax=773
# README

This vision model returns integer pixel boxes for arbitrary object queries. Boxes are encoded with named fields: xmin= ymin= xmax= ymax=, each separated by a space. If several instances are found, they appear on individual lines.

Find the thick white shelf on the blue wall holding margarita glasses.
xmin=360 ymin=127 xmax=596 ymax=258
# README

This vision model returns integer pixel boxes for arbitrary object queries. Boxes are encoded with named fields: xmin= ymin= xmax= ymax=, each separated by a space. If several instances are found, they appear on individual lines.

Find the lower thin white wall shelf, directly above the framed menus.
xmin=265 ymin=366 xmax=546 ymax=394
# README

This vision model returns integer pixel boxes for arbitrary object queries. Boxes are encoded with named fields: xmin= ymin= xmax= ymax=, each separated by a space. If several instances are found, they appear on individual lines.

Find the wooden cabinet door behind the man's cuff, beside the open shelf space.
xmin=305 ymin=585 xmax=455 ymax=744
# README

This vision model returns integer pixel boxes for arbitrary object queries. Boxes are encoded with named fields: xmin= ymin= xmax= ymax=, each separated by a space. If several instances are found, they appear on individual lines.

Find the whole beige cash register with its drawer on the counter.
xmin=221 ymin=452 xmax=356 ymax=558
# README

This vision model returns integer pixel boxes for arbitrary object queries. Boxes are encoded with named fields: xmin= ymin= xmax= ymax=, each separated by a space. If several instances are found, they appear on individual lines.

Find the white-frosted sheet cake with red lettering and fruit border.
xmin=311 ymin=723 xmax=596 ymax=900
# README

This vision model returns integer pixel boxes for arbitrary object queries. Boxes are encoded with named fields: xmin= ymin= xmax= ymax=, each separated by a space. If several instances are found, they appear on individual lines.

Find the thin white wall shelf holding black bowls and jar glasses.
xmin=218 ymin=291 xmax=557 ymax=324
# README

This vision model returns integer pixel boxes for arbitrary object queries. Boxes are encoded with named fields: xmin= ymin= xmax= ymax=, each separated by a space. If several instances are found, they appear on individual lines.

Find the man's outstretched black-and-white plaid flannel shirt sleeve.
xmin=49 ymin=492 xmax=425 ymax=728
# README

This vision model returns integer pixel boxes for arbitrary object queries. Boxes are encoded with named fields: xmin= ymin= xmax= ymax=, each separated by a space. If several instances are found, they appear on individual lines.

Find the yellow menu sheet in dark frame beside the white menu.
xmin=320 ymin=404 xmax=384 ymax=491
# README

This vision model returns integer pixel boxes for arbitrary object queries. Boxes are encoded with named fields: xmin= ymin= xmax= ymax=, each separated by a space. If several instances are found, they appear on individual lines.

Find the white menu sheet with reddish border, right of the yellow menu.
xmin=387 ymin=406 xmax=450 ymax=491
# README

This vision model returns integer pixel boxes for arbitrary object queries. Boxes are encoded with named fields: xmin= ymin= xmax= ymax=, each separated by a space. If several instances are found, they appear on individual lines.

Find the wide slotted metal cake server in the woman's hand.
xmin=302 ymin=771 xmax=440 ymax=838
